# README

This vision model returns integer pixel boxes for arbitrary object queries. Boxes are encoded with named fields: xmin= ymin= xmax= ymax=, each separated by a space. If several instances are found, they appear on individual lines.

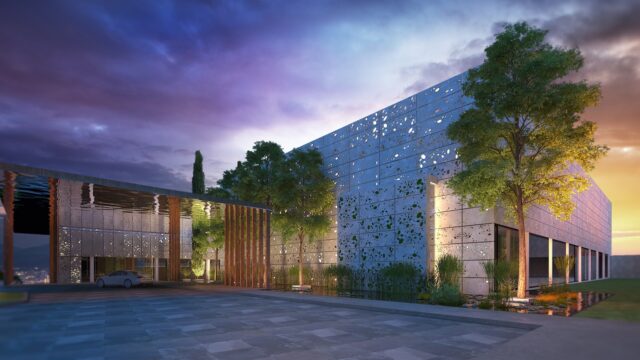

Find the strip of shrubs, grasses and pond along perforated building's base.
xmin=272 ymin=255 xmax=620 ymax=321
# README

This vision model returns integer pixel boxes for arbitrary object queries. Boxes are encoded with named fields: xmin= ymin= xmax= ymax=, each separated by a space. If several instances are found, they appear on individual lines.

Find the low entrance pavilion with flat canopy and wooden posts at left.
xmin=0 ymin=163 xmax=271 ymax=287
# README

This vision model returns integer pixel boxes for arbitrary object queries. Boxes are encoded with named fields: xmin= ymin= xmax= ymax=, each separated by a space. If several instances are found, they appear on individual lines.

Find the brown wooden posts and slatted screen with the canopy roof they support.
xmin=0 ymin=163 xmax=271 ymax=288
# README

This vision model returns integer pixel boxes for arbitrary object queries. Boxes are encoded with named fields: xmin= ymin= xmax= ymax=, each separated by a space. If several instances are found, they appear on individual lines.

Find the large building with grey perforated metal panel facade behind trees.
xmin=271 ymin=74 xmax=611 ymax=294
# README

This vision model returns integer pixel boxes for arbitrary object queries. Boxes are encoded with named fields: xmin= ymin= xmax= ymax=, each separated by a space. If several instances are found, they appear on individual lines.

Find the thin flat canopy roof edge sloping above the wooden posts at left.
xmin=0 ymin=161 xmax=270 ymax=210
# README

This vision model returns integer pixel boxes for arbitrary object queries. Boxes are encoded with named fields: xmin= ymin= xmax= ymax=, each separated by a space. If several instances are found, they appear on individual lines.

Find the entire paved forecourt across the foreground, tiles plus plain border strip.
xmin=0 ymin=284 xmax=640 ymax=360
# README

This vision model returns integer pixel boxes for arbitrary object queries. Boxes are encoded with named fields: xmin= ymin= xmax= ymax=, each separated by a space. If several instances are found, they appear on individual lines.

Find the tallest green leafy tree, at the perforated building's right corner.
xmin=447 ymin=23 xmax=608 ymax=297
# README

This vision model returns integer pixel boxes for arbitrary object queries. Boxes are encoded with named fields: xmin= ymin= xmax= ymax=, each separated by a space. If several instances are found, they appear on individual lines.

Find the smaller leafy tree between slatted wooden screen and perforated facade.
xmin=273 ymin=149 xmax=334 ymax=285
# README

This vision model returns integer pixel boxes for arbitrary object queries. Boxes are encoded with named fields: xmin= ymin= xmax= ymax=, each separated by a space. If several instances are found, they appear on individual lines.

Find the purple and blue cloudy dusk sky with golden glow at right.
xmin=0 ymin=0 xmax=640 ymax=254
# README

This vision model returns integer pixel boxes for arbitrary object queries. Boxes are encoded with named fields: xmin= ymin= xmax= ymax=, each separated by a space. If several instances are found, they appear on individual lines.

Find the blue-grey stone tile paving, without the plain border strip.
xmin=0 ymin=289 xmax=527 ymax=360
